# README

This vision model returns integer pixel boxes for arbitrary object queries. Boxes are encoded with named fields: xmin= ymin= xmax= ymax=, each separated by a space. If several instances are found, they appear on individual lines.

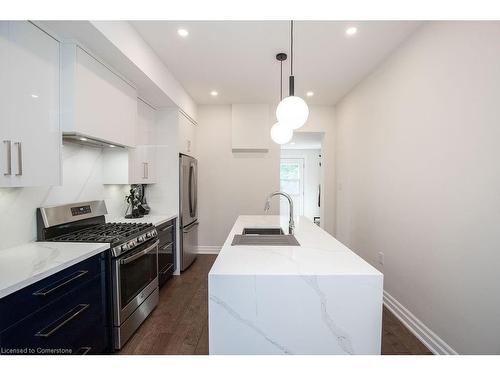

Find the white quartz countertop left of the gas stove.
xmin=0 ymin=242 xmax=109 ymax=298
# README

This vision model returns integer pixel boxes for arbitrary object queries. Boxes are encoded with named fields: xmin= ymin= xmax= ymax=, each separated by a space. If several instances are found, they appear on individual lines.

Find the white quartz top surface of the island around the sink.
xmin=209 ymin=215 xmax=382 ymax=277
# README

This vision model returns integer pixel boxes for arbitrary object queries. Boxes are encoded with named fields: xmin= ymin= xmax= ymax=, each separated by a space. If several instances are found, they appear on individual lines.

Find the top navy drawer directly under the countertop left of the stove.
xmin=0 ymin=253 xmax=105 ymax=331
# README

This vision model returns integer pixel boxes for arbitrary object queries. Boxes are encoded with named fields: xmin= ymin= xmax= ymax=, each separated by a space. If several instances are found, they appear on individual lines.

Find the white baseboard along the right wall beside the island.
xmin=384 ymin=291 xmax=458 ymax=355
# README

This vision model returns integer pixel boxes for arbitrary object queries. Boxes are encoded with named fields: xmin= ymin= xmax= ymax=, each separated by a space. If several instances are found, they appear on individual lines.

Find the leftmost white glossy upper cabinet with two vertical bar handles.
xmin=0 ymin=21 xmax=61 ymax=186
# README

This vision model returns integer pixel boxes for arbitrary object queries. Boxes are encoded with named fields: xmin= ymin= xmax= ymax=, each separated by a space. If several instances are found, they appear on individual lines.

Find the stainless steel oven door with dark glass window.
xmin=113 ymin=239 xmax=159 ymax=326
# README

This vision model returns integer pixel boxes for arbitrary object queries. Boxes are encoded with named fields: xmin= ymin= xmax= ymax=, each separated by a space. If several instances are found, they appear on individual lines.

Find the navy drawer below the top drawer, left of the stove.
xmin=0 ymin=275 xmax=107 ymax=354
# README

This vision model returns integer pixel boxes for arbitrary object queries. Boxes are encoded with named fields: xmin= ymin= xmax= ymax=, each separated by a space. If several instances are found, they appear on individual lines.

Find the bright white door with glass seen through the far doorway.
xmin=280 ymin=158 xmax=304 ymax=216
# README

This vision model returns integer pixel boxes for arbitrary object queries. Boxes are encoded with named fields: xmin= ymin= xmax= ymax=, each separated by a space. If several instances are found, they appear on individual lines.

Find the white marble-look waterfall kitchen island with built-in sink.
xmin=208 ymin=216 xmax=383 ymax=354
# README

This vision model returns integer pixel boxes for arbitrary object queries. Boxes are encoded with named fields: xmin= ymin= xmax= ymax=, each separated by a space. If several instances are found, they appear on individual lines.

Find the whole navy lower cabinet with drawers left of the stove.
xmin=0 ymin=256 xmax=110 ymax=354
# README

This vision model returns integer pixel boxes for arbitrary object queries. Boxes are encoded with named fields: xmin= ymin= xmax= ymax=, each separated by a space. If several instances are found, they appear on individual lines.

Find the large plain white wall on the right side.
xmin=336 ymin=22 xmax=500 ymax=354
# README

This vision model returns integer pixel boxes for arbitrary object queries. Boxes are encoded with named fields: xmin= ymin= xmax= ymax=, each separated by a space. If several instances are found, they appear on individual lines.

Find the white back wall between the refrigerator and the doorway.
xmin=197 ymin=105 xmax=280 ymax=248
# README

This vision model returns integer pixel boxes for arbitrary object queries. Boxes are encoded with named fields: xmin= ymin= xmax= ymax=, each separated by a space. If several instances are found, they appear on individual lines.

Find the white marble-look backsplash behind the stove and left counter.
xmin=0 ymin=143 xmax=129 ymax=250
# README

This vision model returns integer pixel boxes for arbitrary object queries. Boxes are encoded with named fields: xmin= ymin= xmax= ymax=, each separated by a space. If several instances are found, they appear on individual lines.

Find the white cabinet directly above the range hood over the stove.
xmin=62 ymin=44 xmax=137 ymax=147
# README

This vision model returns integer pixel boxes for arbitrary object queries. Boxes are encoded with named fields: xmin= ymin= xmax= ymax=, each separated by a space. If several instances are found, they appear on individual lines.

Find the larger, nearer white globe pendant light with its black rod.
xmin=276 ymin=21 xmax=309 ymax=130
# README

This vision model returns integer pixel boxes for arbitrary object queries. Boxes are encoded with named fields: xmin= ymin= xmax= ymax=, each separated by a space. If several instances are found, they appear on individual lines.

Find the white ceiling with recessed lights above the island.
xmin=131 ymin=21 xmax=421 ymax=105
